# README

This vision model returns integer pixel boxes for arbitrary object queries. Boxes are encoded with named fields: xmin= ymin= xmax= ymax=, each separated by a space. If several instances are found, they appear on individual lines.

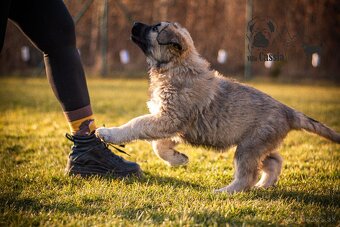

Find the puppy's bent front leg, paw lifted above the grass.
xmin=151 ymin=139 xmax=189 ymax=166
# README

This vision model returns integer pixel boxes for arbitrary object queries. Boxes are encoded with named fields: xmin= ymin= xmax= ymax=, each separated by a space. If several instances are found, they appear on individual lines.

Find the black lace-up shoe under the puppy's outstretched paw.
xmin=66 ymin=134 xmax=142 ymax=177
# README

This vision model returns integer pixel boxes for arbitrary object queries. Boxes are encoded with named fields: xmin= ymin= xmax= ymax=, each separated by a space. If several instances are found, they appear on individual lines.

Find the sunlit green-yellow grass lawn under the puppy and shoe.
xmin=0 ymin=78 xmax=340 ymax=226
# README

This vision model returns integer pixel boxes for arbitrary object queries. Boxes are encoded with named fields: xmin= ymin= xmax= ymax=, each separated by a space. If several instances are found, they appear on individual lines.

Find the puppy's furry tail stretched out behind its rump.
xmin=289 ymin=109 xmax=340 ymax=143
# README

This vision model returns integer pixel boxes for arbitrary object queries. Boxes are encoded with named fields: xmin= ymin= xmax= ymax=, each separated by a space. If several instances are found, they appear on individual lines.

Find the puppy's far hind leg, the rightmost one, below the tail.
xmin=255 ymin=152 xmax=283 ymax=188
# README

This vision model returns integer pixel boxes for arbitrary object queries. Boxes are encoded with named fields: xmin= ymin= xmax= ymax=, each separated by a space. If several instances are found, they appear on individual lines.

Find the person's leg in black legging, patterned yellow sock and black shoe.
xmin=9 ymin=0 xmax=140 ymax=176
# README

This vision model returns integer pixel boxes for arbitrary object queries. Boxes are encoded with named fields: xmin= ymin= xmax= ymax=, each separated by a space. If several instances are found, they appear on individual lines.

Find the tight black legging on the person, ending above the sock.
xmin=0 ymin=0 xmax=90 ymax=111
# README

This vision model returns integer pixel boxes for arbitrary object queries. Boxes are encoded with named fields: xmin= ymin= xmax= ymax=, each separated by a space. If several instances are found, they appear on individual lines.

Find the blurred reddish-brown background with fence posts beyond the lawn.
xmin=0 ymin=0 xmax=340 ymax=82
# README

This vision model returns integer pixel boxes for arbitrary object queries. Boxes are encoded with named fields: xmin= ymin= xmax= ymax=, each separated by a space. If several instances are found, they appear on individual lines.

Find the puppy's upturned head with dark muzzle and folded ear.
xmin=131 ymin=22 xmax=194 ymax=66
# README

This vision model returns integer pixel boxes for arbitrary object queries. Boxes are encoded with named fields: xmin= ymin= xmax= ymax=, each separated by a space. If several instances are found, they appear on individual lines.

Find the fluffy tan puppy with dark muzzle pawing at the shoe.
xmin=96 ymin=22 xmax=340 ymax=193
